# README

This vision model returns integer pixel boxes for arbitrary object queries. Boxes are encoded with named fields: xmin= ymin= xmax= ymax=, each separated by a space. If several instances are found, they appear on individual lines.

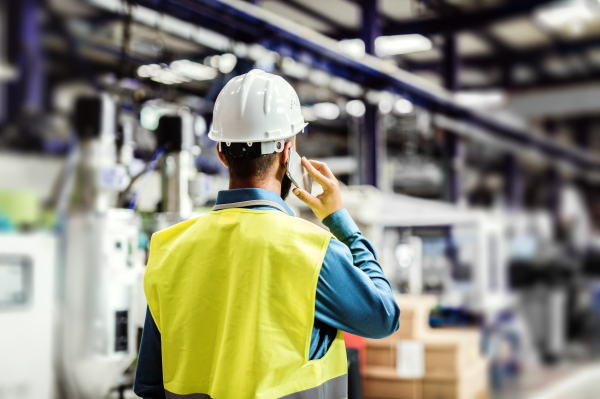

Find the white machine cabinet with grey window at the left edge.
xmin=0 ymin=233 xmax=56 ymax=399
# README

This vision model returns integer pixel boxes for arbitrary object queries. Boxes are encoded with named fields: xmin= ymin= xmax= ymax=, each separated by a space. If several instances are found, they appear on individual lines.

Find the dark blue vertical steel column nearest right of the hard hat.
xmin=360 ymin=0 xmax=381 ymax=187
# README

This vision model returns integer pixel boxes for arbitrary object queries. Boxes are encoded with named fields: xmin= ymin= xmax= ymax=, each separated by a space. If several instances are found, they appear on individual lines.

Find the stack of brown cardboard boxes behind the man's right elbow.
xmin=364 ymin=296 xmax=488 ymax=399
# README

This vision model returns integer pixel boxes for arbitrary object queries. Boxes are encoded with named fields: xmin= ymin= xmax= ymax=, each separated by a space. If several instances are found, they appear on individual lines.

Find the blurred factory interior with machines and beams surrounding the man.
xmin=0 ymin=0 xmax=600 ymax=399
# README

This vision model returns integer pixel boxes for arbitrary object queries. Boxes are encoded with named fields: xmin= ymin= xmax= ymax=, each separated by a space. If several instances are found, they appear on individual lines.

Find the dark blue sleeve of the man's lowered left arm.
xmin=133 ymin=308 xmax=165 ymax=399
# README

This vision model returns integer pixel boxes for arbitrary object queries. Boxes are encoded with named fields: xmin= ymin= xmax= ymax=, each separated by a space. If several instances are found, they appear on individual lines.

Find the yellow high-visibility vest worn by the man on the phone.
xmin=144 ymin=208 xmax=347 ymax=399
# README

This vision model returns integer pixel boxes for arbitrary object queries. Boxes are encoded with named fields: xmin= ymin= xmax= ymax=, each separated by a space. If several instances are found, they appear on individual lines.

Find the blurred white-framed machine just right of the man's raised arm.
xmin=382 ymin=194 xmax=513 ymax=320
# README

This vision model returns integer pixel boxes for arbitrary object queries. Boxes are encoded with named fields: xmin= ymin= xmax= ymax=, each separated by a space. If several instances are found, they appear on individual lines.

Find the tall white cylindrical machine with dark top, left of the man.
xmin=59 ymin=94 xmax=143 ymax=399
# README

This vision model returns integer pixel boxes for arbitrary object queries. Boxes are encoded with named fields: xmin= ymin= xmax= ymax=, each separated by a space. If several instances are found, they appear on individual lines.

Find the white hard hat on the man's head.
xmin=208 ymin=69 xmax=308 ymax=154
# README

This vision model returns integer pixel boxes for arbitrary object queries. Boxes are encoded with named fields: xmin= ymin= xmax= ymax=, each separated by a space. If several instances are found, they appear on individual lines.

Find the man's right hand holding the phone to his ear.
xmin=293 ymin=157 xmax=344 ymax=220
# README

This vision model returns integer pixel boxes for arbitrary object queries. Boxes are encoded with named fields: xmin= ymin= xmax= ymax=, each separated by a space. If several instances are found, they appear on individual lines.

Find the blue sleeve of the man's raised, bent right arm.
xmin=315 ymin=209 xmax=400 ymax=339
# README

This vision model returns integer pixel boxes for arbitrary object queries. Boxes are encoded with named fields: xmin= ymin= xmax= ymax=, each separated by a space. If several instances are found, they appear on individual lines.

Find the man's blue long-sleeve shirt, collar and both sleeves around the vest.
xmin=134 ymin=188 xmax=400 ymax=399
